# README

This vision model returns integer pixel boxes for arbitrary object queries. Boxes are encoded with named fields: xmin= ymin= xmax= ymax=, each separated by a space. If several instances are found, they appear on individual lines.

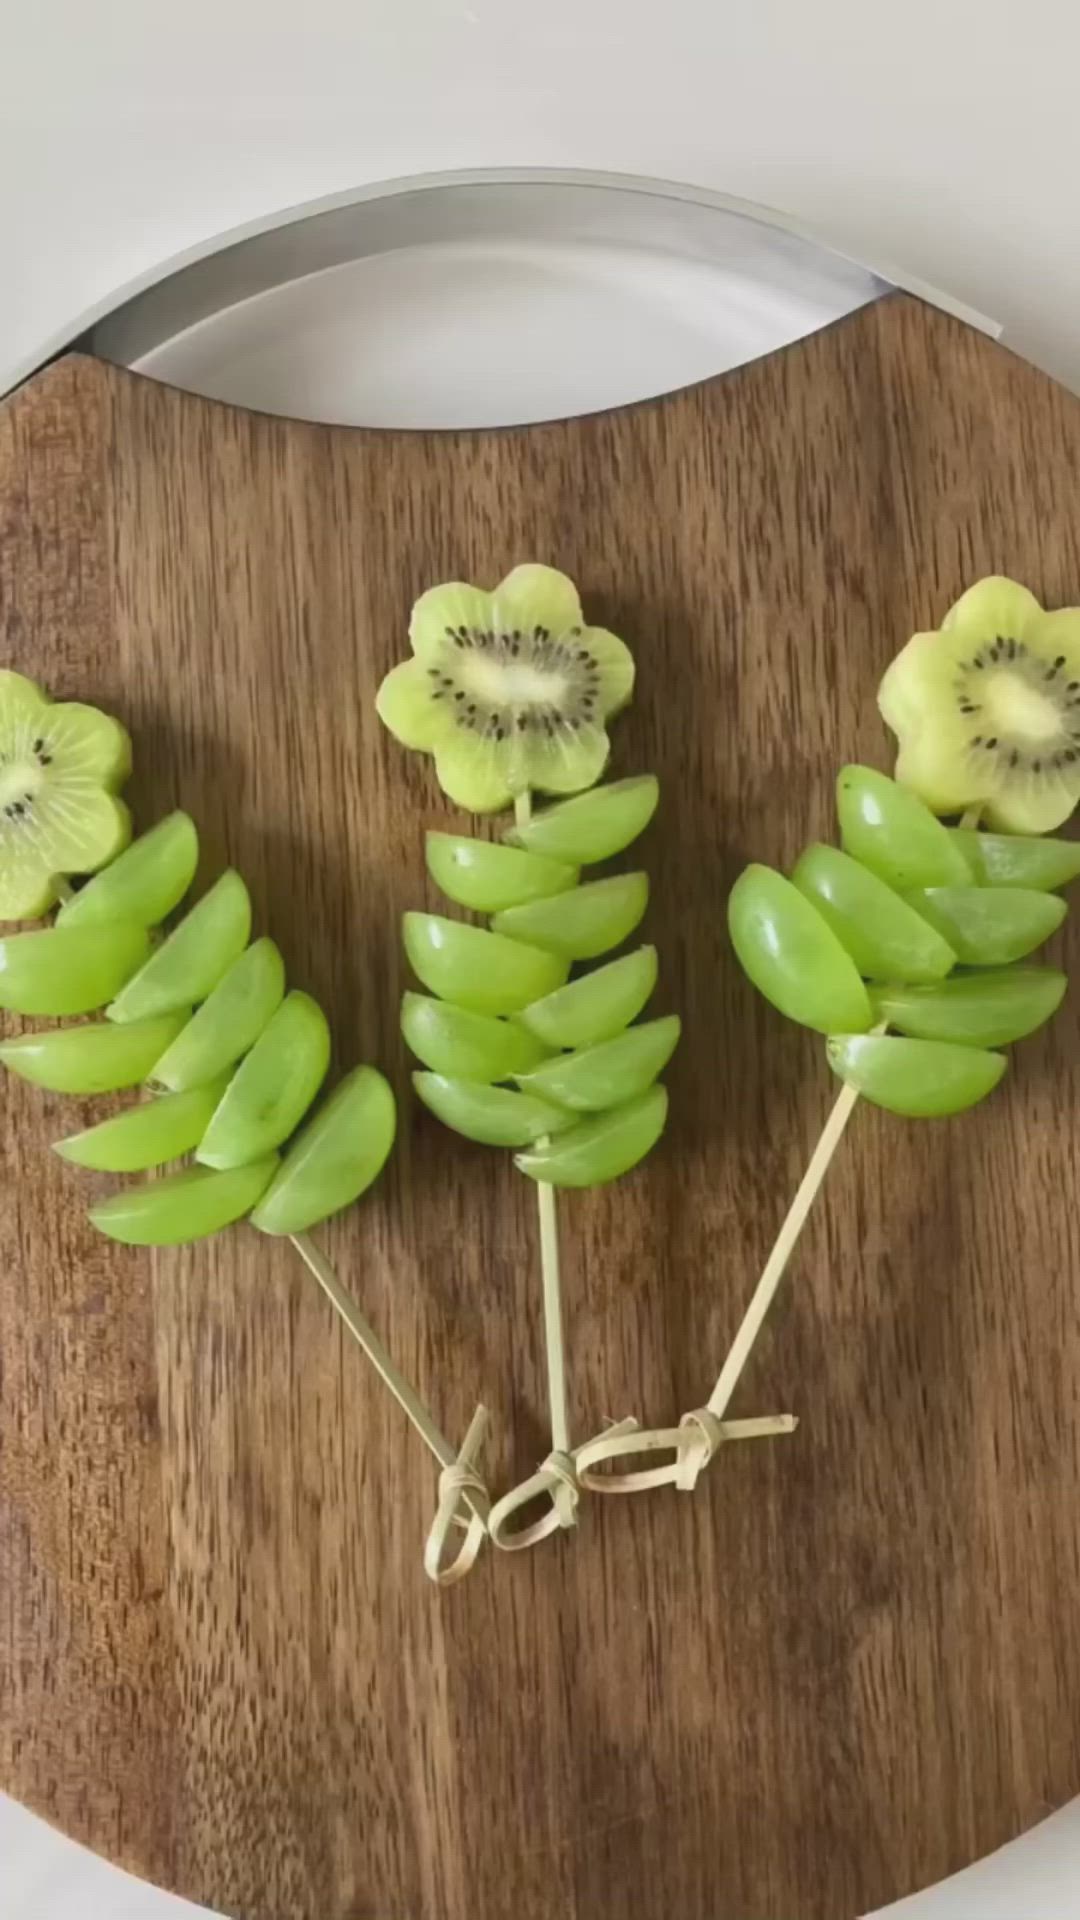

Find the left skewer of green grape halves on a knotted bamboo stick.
xmin=0 ymin=676 xmax=488 ymax=1586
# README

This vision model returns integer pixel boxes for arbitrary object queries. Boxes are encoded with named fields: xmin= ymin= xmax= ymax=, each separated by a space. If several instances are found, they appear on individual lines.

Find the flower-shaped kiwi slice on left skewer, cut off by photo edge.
xmin=0 ymin=670 xmax=131 ymax=920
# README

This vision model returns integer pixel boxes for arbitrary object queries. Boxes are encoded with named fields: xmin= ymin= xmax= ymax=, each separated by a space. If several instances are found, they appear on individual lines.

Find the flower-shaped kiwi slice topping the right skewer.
xmin=878 ymin=576 xmax=1080 ymax=833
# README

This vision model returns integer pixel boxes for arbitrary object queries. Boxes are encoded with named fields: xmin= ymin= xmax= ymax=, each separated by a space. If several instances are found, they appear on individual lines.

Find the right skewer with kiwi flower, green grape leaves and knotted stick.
xmin=578 ymin=580 xmax=1080 ymax=1494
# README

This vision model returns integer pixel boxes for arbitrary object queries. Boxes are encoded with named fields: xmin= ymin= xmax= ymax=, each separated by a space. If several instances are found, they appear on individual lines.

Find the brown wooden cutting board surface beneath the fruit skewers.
xmin=0 ymin=296 xmax=1080 ymax=1920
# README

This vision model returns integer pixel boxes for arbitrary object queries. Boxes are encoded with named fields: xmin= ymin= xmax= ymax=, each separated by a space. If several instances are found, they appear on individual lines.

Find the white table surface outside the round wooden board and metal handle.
xmin=0 ymin=0 xmax=1080 ymax=1920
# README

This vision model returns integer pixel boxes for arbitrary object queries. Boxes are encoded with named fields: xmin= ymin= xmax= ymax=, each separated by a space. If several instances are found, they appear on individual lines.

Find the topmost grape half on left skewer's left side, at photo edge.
xmin=0 ymin=920 xmax=150 ymax=1018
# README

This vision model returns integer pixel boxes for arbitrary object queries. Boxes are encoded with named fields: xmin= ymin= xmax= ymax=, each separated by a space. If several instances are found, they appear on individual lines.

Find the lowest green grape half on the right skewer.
xmin=828 ymin=1033 xmax=1007 ymax=1119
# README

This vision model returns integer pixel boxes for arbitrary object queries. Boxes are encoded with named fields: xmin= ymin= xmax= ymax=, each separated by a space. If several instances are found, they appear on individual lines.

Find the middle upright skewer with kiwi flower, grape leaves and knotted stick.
xmin=377 ymin=566 xmax=678 ymax=1551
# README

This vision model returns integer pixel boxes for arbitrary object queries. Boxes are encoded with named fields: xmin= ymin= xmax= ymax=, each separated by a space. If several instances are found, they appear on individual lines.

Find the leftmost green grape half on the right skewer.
xmin=728 ymin=866 xmax=874 ymax=1033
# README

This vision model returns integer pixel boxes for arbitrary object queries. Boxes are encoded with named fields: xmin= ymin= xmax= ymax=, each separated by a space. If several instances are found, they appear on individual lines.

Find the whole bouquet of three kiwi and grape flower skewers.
xmin=0 ymin=564 xmax=1080 ymax=1584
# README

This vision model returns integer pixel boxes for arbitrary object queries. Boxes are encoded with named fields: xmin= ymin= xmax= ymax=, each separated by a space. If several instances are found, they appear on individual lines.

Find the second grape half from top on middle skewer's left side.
xmin=402 ymin=914 xmax=571 ymax=1014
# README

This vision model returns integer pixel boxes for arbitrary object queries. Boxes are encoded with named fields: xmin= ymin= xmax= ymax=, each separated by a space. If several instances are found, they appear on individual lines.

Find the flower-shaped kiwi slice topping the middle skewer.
xmin=377 ymin=564 xmax=634 ymax=814
